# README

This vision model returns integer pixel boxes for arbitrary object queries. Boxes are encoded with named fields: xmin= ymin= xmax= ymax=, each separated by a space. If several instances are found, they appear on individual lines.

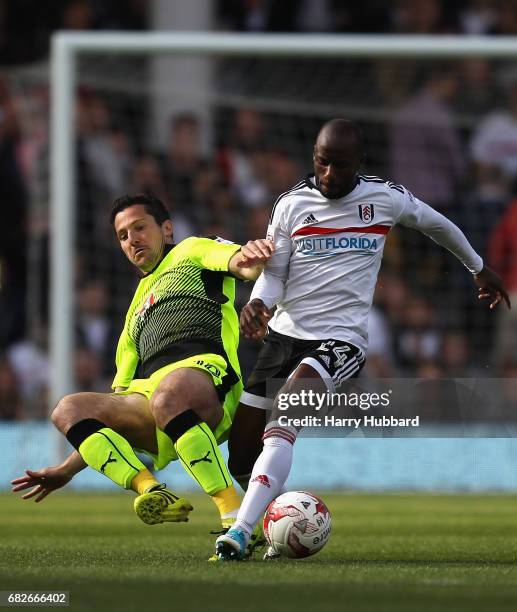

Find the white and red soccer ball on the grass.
xmin=264 ymin=491 xmax=332 ymax=559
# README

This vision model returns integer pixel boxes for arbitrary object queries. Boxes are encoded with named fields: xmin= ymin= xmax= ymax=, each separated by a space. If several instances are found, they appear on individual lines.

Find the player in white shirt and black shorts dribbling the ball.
xmin=216 ymin=119 xmax=510 ymax=560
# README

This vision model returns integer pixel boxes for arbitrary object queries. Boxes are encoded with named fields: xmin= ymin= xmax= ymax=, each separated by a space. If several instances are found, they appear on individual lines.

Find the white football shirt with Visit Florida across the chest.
xmin=250 ymin=175 xmax=483 ymax=351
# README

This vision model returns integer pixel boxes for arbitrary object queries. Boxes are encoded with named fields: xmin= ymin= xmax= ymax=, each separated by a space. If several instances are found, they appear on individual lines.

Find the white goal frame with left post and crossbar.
xmin=49 ymin=32 xmax=517 ymax=407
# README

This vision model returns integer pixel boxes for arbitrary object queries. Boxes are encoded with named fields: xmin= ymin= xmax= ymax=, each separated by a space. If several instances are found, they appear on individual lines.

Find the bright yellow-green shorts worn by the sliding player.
xmin=115 ymin=353 xmax=242 ymax=470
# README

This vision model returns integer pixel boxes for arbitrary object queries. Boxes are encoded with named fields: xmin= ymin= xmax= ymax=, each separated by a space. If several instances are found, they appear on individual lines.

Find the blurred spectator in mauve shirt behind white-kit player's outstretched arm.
xmin=390 ymin=64 xmax=466 ymax=302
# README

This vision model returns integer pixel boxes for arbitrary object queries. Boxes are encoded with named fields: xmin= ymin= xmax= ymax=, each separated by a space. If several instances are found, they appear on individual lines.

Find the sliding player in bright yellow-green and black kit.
xmin=13 ymin=194 xmax=272 ymax=527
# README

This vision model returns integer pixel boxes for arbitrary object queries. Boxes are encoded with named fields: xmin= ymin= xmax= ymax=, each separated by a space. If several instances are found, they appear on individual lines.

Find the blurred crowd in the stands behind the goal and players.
xmin=0 ymin=0 xmax=517 ymax=420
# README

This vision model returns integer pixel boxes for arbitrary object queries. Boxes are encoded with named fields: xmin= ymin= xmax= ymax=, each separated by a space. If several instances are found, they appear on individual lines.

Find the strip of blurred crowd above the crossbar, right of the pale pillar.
xmin=218 ymin=0 xmax=517 ymax=35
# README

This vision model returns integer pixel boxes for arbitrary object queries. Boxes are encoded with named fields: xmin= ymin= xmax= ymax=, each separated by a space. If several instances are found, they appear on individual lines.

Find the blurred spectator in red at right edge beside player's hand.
xmin=488 ymin=199 xmax=517 ymax=366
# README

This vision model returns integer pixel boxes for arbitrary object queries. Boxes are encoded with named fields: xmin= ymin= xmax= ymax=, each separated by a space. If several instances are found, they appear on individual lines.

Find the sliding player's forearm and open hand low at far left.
xmin=11 ymin=451 xmax=86 ymax=502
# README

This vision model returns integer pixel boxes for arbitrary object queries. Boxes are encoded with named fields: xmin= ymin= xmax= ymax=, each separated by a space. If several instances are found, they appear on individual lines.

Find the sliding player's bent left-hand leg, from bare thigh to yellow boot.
xmin=52 ymin=393 xmax=192 ymax=522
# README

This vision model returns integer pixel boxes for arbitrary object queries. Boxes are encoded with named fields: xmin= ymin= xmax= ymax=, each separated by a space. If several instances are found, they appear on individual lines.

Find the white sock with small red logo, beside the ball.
xmin=234 ymin=422 xmax=297 ymax=535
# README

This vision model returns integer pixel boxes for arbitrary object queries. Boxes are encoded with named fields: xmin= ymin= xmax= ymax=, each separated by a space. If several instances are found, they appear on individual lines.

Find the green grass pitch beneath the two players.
xmin=0 ymin=492 xmax=517 ymax=612
